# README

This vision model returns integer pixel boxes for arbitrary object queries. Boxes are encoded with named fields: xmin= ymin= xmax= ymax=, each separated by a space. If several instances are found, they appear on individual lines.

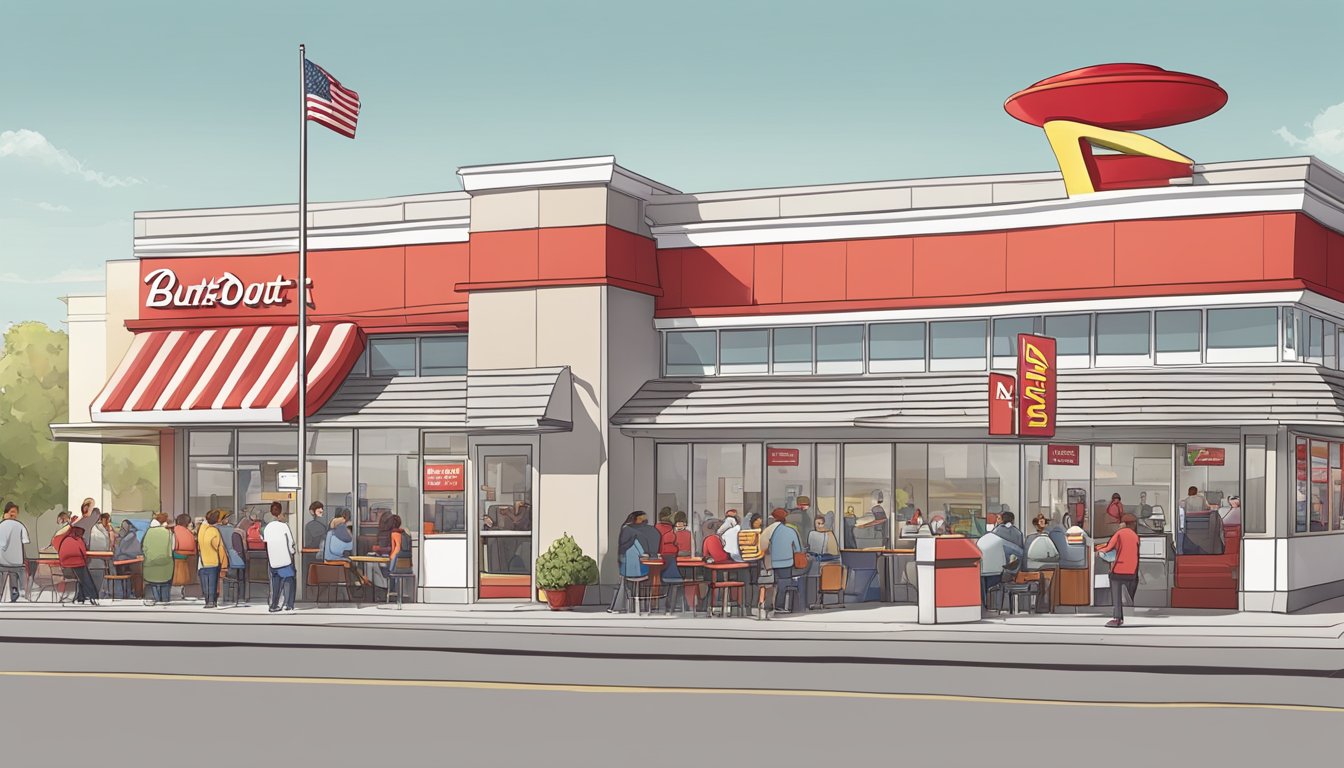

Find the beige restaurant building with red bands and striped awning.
xmin=52 ymin=148 xmax=1344 ymax=612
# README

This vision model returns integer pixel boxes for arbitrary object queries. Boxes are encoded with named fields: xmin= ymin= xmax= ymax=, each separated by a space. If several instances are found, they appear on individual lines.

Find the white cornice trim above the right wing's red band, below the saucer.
xmin=653 ymin=182 xmax=1322 ymax=249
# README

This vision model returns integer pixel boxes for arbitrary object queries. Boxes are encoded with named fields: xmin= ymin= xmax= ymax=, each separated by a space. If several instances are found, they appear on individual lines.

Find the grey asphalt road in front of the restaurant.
xmin=0 ymin=617 xmax=1344 ymax=768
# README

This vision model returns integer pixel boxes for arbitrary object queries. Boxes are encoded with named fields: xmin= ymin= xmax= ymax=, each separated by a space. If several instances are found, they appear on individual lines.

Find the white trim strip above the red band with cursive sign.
xmin=133 ymin=217 xmax=469 ymax=258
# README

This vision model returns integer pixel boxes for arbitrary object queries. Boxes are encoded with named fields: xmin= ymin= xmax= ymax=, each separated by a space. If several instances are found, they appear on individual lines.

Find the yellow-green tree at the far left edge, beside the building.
xmin=0 ymin=323 xmax=70 ymax=515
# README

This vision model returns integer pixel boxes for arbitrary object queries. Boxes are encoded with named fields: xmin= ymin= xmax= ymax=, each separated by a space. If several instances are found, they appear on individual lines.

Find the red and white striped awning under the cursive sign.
xmin=90 ymin=323 xmax=364 ymax=425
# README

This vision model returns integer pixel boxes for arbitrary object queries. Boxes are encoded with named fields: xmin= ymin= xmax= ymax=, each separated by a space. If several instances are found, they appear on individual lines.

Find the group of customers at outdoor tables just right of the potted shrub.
xmin=607 ymin=508 xmax=840 ymax=613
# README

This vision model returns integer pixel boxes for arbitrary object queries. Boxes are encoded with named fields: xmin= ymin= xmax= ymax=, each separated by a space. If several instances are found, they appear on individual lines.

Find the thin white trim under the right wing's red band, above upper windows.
xmin=653 ymin=291 xmax=1300 ymax=332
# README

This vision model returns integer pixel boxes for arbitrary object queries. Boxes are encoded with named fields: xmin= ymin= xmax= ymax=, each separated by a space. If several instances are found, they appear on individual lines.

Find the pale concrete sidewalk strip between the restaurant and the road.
xmin=0 ymin=599 xmax=1344 ymax=648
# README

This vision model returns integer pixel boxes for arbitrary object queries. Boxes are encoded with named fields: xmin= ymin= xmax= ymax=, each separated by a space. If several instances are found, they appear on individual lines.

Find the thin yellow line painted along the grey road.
xmin=0 ymin=671 xmax=1344 ymax=714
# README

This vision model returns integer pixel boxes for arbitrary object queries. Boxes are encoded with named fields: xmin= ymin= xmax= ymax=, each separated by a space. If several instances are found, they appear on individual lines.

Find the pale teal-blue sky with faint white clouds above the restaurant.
xmin=0 ymin=0 xmax=1344 ymax=327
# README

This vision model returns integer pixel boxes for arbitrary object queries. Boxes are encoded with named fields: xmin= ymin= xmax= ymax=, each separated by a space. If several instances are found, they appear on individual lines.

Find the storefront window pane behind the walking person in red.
xmin=1089 ymin=443 xmax=1173 ymax=538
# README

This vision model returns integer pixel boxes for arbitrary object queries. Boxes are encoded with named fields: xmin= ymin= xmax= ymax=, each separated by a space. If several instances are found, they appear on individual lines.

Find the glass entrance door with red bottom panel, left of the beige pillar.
xmin=476 ymin=445 xmax=534 ymax=600
